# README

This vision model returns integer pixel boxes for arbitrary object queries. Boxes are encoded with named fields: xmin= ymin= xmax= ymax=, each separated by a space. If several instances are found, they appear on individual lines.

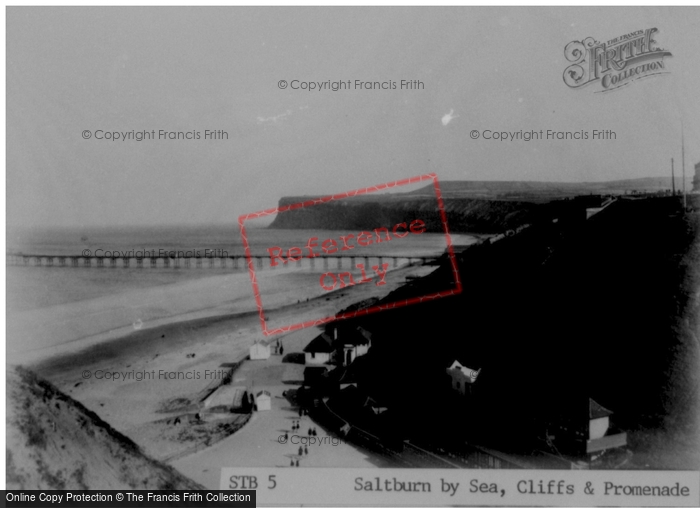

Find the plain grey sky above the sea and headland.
xmin=6 ymin=7 xmax=700 ymax=228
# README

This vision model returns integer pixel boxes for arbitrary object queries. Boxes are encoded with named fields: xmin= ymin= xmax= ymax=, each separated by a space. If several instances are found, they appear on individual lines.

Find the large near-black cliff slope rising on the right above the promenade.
xmin=348 ymin=198 xmax=700 ymax=468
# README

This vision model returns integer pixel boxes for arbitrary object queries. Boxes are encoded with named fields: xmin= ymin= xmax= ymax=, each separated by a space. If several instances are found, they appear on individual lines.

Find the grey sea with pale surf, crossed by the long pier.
xmin=6 ymin=225 xmax=478 ymax=358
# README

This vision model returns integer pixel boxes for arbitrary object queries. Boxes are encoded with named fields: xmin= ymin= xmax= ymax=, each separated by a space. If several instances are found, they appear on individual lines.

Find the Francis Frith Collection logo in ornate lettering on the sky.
xmin=564 ymin=28 xmax=672 ymax=93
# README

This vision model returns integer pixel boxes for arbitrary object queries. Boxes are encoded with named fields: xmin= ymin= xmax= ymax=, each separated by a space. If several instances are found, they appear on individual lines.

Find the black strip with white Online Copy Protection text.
xmin=0 ymin=490 xmax=255 ymax=508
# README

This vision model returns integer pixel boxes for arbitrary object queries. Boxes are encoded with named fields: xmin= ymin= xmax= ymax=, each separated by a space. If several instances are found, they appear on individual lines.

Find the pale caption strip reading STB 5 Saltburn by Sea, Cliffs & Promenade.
xmin=219 ymin=468 xmax=700 ymax=507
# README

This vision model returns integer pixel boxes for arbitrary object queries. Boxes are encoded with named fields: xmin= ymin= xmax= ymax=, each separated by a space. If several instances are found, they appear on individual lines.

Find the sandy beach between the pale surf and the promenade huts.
xmin=21 ymin=266 xmax=440 ymax=466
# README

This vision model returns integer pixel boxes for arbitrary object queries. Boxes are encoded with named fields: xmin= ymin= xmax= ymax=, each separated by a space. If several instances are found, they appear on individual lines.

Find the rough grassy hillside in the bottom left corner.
xmin=6 ymin=367 xmax=203 ymax=490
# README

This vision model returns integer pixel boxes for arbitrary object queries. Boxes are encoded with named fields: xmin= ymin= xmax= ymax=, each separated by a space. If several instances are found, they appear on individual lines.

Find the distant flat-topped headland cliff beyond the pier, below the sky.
xmin=270 ymin=177 xmax=690 ymax=234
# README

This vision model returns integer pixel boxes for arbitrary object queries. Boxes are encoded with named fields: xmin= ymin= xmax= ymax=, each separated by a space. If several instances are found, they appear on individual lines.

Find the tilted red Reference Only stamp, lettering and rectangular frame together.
xmin=238 ymin=173 xmax=462 ymax=336
